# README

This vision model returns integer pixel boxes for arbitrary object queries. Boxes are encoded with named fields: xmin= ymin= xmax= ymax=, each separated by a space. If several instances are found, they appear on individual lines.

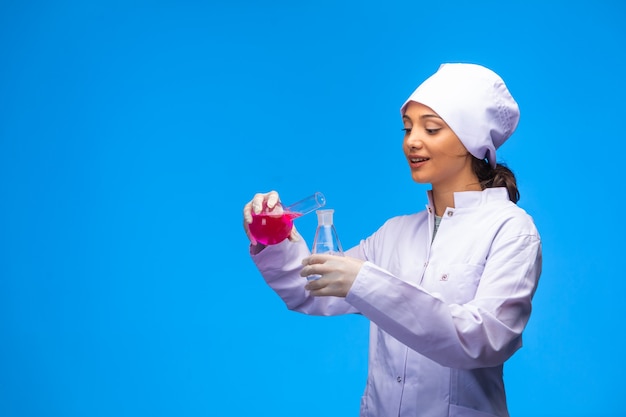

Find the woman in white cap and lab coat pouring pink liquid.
xmin=243 ymin=64 xmax=541 ymax=417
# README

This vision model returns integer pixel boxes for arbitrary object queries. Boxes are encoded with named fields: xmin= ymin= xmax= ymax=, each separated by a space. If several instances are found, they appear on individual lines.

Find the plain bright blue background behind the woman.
xmin=0 ymin=0 xmax=626 ymax=417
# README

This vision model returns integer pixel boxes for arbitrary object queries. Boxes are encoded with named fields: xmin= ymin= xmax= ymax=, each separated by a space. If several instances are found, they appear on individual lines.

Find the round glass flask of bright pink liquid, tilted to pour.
xmin=249 ymin=191 xmax=326 ymax=245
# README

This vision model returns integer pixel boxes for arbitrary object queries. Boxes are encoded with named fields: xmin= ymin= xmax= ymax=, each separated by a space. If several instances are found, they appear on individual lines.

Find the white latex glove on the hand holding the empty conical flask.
xmin=300 ymin=254 xmax=365 ymax=297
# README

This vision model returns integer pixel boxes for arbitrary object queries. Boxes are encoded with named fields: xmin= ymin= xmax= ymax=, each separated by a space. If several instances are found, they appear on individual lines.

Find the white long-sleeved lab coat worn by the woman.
xmin=252 ymin=188 xmax=541 ymax=417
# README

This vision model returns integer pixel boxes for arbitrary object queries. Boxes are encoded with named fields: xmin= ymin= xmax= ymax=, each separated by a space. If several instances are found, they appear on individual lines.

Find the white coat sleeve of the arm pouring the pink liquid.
xmin=251 ymin=240 xmax=358 ymax=316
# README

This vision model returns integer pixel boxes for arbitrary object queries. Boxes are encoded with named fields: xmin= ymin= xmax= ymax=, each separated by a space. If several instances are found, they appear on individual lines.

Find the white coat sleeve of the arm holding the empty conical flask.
xmin=346 ymin=219 xmax=542 ymax=369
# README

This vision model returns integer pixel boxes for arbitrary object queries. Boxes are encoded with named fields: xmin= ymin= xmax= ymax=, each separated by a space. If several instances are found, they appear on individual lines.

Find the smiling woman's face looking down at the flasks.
xmin=402 ymin=101 xmax=480 ymax=191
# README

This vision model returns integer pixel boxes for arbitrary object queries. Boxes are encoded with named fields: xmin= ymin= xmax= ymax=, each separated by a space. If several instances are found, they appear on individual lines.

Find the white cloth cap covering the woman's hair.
xmin=400 ymin=64 xmax=519 ymax=167
